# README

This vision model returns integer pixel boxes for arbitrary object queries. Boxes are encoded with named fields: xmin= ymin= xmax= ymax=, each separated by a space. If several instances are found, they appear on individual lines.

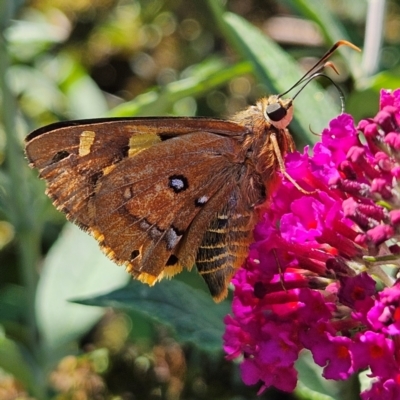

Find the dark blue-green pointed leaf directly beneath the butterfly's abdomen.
xmin=75 ymin=279 xmax=230 ymax=351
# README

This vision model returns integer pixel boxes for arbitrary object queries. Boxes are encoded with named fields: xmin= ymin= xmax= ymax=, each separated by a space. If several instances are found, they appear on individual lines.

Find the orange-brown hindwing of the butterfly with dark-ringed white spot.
xmin=91 ymin=132 xmax=239 ymax=283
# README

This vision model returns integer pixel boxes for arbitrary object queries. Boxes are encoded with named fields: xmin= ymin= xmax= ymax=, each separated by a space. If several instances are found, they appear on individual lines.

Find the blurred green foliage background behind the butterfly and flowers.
xmin=0 ymin=0 xmax=400 ymax=400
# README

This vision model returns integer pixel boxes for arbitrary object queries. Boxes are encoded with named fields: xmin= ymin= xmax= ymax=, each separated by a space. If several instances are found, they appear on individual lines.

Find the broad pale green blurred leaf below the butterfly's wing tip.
xmin=36 ymin=224 xmax=130 ymax=362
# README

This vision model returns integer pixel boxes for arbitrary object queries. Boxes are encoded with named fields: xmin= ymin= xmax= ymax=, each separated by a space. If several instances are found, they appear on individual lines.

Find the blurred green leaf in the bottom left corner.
xmin=0 ymin=329 xmax=44 ymax=398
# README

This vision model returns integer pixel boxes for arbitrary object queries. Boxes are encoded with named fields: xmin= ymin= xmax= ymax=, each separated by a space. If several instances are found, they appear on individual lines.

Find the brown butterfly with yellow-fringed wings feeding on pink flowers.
xmin=26 ymin=40 xmax=355 ymax=301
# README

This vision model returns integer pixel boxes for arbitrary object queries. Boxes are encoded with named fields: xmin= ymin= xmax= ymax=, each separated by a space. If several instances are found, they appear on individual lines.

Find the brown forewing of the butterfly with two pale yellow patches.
xmin=26 ymin=118 xmax=243 ymax=229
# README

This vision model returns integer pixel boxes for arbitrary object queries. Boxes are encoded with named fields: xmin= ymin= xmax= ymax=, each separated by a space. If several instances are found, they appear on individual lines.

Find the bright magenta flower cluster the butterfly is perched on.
xmin=224 ymin=90 xmax=400 ymax=400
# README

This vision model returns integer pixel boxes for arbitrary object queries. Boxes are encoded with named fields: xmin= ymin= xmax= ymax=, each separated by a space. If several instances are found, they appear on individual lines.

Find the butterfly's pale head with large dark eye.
xmin=260 ymin=96 xmax=293 ymax=129
